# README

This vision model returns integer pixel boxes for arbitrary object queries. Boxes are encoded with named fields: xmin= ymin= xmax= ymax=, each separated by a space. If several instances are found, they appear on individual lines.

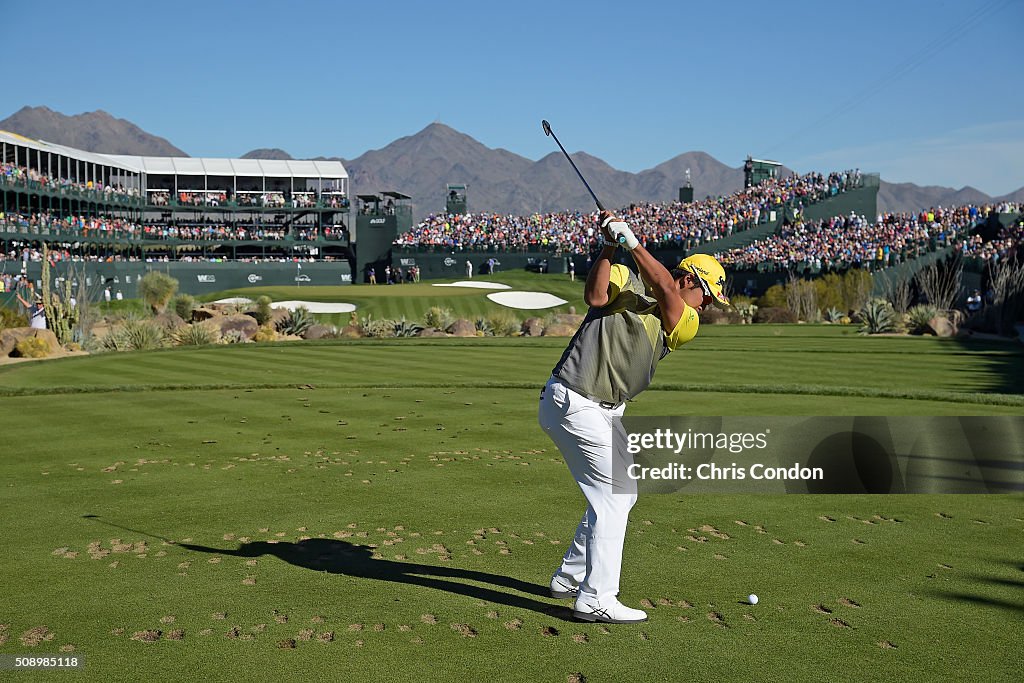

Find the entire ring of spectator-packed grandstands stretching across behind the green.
xmin=0 ymin=126 xmax=1024 ymax=296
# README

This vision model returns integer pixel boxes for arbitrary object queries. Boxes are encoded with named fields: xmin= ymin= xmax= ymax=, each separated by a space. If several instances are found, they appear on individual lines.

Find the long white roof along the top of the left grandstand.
xmin=0 ymin=130 xmax=348 ymax=179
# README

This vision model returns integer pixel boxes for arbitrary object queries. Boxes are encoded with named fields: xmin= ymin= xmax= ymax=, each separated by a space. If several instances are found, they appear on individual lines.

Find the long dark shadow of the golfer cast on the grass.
xmin=178 ymin=539 xmax=572 ymax=621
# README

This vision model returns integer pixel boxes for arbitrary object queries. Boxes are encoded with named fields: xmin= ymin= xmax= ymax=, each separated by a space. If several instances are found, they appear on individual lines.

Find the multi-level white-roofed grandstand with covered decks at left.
xmin=0 ymin=131 xmax=352 ymax=295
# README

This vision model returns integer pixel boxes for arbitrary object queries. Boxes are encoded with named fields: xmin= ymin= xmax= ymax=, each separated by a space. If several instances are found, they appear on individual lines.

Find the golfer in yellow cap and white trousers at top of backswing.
xmin=539 ymin=212 xmax=729 ymax=624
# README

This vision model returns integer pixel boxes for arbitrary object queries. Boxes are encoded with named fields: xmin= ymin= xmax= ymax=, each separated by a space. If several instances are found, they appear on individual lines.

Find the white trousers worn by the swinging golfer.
xmin=538 ymin=378 xmax=637 ymax=604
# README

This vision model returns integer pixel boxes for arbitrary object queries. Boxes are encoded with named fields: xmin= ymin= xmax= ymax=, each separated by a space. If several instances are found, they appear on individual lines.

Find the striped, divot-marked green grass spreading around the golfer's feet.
xmin=0 ymin=327 xmax=1024 ymax=682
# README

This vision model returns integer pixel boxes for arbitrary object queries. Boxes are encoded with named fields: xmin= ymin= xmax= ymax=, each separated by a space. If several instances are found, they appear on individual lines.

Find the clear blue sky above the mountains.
xmin=0 ymin=0 xmax=1024 ymax=196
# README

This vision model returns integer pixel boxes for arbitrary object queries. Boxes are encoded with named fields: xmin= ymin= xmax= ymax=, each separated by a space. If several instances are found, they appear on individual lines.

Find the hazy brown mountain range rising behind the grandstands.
xmin=0 ymin=106 xmax=1024 ymax=218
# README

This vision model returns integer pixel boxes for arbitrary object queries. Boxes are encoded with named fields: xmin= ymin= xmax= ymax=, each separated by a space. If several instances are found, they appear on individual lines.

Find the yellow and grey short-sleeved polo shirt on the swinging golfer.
xmin=552 ymin=264 xmax=698 ymax=404
